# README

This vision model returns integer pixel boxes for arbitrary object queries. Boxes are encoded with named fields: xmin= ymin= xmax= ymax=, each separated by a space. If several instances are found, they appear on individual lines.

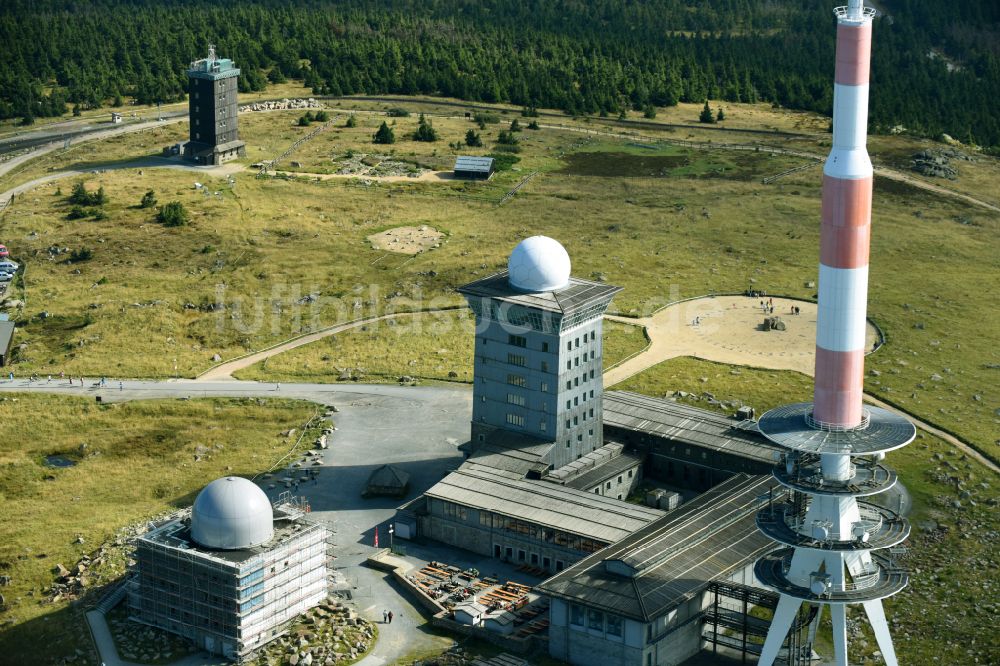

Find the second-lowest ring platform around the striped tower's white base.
xmin=757 ymin=501 xmax=910 ymax=551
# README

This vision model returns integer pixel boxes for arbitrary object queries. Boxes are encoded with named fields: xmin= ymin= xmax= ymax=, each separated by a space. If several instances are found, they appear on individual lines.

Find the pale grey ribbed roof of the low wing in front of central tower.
xmin=425 ymin=465 xmax=664 ymax=543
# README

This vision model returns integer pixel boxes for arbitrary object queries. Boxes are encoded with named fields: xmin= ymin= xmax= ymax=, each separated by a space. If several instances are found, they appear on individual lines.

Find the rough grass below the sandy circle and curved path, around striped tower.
xmin=614 ymin=358 xmax=1000 ymax=664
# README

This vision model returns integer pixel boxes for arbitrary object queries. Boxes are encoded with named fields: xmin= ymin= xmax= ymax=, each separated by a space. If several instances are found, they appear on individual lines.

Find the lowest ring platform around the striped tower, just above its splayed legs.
xmin=754 ymin=548 xmax=909 ymax=603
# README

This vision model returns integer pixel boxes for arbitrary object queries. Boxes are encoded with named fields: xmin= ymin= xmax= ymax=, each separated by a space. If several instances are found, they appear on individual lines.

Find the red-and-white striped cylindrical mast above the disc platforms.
xmin=813 ymin=0 xmax=872 ymax=428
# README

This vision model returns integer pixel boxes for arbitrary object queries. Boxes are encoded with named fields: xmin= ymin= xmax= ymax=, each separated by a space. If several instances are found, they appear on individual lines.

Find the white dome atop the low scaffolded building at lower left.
xmin=191 ymin=476 xmax=274 ymax=550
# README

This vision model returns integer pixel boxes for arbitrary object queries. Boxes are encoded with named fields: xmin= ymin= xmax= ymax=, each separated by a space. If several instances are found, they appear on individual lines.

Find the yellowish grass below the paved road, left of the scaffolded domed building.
xmin=0 ymin=394 xmax=314 ymax=664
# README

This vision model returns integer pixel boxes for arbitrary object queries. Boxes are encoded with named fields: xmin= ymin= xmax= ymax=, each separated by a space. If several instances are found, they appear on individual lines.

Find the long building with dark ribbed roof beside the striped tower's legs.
xmin=536 ymin=474 xmax=777 ymax=666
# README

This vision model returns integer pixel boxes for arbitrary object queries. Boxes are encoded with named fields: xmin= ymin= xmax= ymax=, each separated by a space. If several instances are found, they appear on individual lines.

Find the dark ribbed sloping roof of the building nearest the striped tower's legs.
xmin=537 ymin=474 xmax=776 ymax=622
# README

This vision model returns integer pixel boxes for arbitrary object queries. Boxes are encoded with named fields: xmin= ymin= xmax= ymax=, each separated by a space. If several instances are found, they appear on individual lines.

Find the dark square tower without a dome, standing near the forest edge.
xmin=184 ymin=45 xmax=246 ymax=164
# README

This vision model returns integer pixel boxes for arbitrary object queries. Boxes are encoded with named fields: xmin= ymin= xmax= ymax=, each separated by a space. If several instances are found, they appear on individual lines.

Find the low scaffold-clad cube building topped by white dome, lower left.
xmin=129 ymin=477 xmax=327 ymax=660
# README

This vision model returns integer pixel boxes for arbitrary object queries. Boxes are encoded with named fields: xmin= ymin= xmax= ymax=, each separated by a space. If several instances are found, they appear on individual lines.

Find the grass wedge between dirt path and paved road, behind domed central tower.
xmin=235 ymin=309 xmax=648 ymax=383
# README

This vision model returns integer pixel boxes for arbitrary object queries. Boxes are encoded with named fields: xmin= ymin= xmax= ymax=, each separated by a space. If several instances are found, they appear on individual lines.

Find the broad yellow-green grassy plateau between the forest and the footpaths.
xmin=0 ymin=101 xmax=1000 ymax=458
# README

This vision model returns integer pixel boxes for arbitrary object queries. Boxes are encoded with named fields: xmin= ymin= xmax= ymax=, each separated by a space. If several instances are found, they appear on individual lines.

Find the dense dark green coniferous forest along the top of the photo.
xmin=0 ymin=0 xmax=1000 ymax=147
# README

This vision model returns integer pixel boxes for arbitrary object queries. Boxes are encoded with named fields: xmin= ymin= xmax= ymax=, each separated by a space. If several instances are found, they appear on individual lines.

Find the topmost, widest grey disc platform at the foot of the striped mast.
xmin=757 ymin=402 xmax=917 ymax=455
